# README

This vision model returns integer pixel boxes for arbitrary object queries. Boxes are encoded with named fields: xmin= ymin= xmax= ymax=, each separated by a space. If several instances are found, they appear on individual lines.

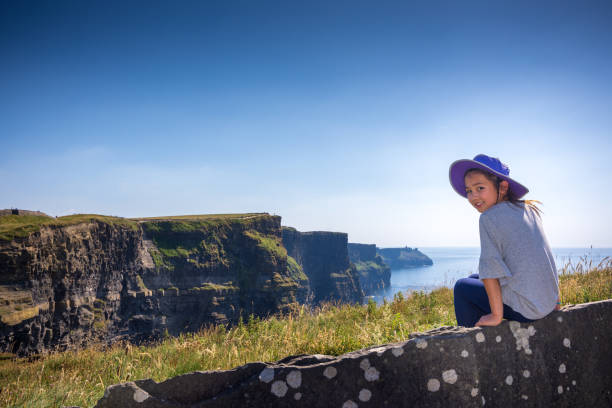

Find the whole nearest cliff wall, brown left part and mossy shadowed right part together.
xmin=0 ymin=214 xmax=308 ymax=355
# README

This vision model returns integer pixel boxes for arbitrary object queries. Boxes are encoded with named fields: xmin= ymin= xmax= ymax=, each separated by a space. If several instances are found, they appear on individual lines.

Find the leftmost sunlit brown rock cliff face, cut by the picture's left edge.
xmin=0 ymin=221 xmax=141 ymax=355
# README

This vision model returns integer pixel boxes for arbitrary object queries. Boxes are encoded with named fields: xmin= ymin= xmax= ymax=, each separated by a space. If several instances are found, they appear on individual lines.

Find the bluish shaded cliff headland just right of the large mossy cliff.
xmin=283 ymin=227 xmax=363 ymax=303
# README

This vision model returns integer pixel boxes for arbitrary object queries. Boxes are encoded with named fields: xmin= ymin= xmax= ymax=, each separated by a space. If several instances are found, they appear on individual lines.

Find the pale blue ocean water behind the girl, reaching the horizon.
xmin=372 ymin=247 xmax=612 ymax=303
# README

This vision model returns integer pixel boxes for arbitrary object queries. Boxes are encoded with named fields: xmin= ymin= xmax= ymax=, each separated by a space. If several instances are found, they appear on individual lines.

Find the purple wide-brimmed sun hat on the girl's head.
xmin=448 ymin=154 xmax=529 ymax=199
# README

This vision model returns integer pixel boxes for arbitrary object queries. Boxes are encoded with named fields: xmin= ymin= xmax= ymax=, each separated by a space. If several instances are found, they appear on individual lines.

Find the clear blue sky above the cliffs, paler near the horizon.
xmin=0 ymin=1 xmax=612 ymax=247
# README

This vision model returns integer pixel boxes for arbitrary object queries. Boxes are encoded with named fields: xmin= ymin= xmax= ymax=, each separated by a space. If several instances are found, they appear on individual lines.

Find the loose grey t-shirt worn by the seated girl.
xmin=478 ymin=201 xmax=559 ymax=319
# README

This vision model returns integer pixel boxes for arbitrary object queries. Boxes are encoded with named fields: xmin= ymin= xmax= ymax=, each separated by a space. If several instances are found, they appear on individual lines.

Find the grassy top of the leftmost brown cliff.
xmin=0 ymin=214 xmax=138 ymax=241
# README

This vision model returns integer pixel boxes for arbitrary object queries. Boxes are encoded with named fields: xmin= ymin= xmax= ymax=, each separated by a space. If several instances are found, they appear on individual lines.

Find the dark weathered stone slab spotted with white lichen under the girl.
xmin=96 ymin=300 xmax=612 ymax=408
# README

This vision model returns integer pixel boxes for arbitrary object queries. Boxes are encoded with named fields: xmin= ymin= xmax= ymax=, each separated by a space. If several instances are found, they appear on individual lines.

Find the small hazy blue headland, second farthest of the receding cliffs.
xmin=348 ymin=243 xmax=391 ymax=295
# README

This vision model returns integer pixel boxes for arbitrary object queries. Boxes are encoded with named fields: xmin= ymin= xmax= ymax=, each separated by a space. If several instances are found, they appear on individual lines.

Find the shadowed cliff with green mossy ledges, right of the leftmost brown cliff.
xmin=130 ymin=216 xmax=308 ymax=342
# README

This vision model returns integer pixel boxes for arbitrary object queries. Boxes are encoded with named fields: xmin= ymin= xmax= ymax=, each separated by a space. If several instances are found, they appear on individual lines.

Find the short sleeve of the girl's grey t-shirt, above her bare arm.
xmin=478 ymin=216 xmax=512 ymax=279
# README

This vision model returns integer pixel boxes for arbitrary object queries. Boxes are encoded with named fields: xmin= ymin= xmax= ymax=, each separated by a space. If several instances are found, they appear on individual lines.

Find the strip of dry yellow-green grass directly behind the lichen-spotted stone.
xmin=0 ymin=260 xmax=612 ymax=407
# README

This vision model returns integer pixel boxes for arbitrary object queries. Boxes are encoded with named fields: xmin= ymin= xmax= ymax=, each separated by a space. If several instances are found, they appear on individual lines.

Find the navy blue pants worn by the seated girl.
xmin=454 ymin=273 xmax=533 ymax=327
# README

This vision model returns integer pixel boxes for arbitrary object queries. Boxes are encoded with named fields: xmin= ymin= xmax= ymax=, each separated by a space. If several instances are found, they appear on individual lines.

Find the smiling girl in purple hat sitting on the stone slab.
xmin=449 ymin=154 xmax=559 ymax=327
